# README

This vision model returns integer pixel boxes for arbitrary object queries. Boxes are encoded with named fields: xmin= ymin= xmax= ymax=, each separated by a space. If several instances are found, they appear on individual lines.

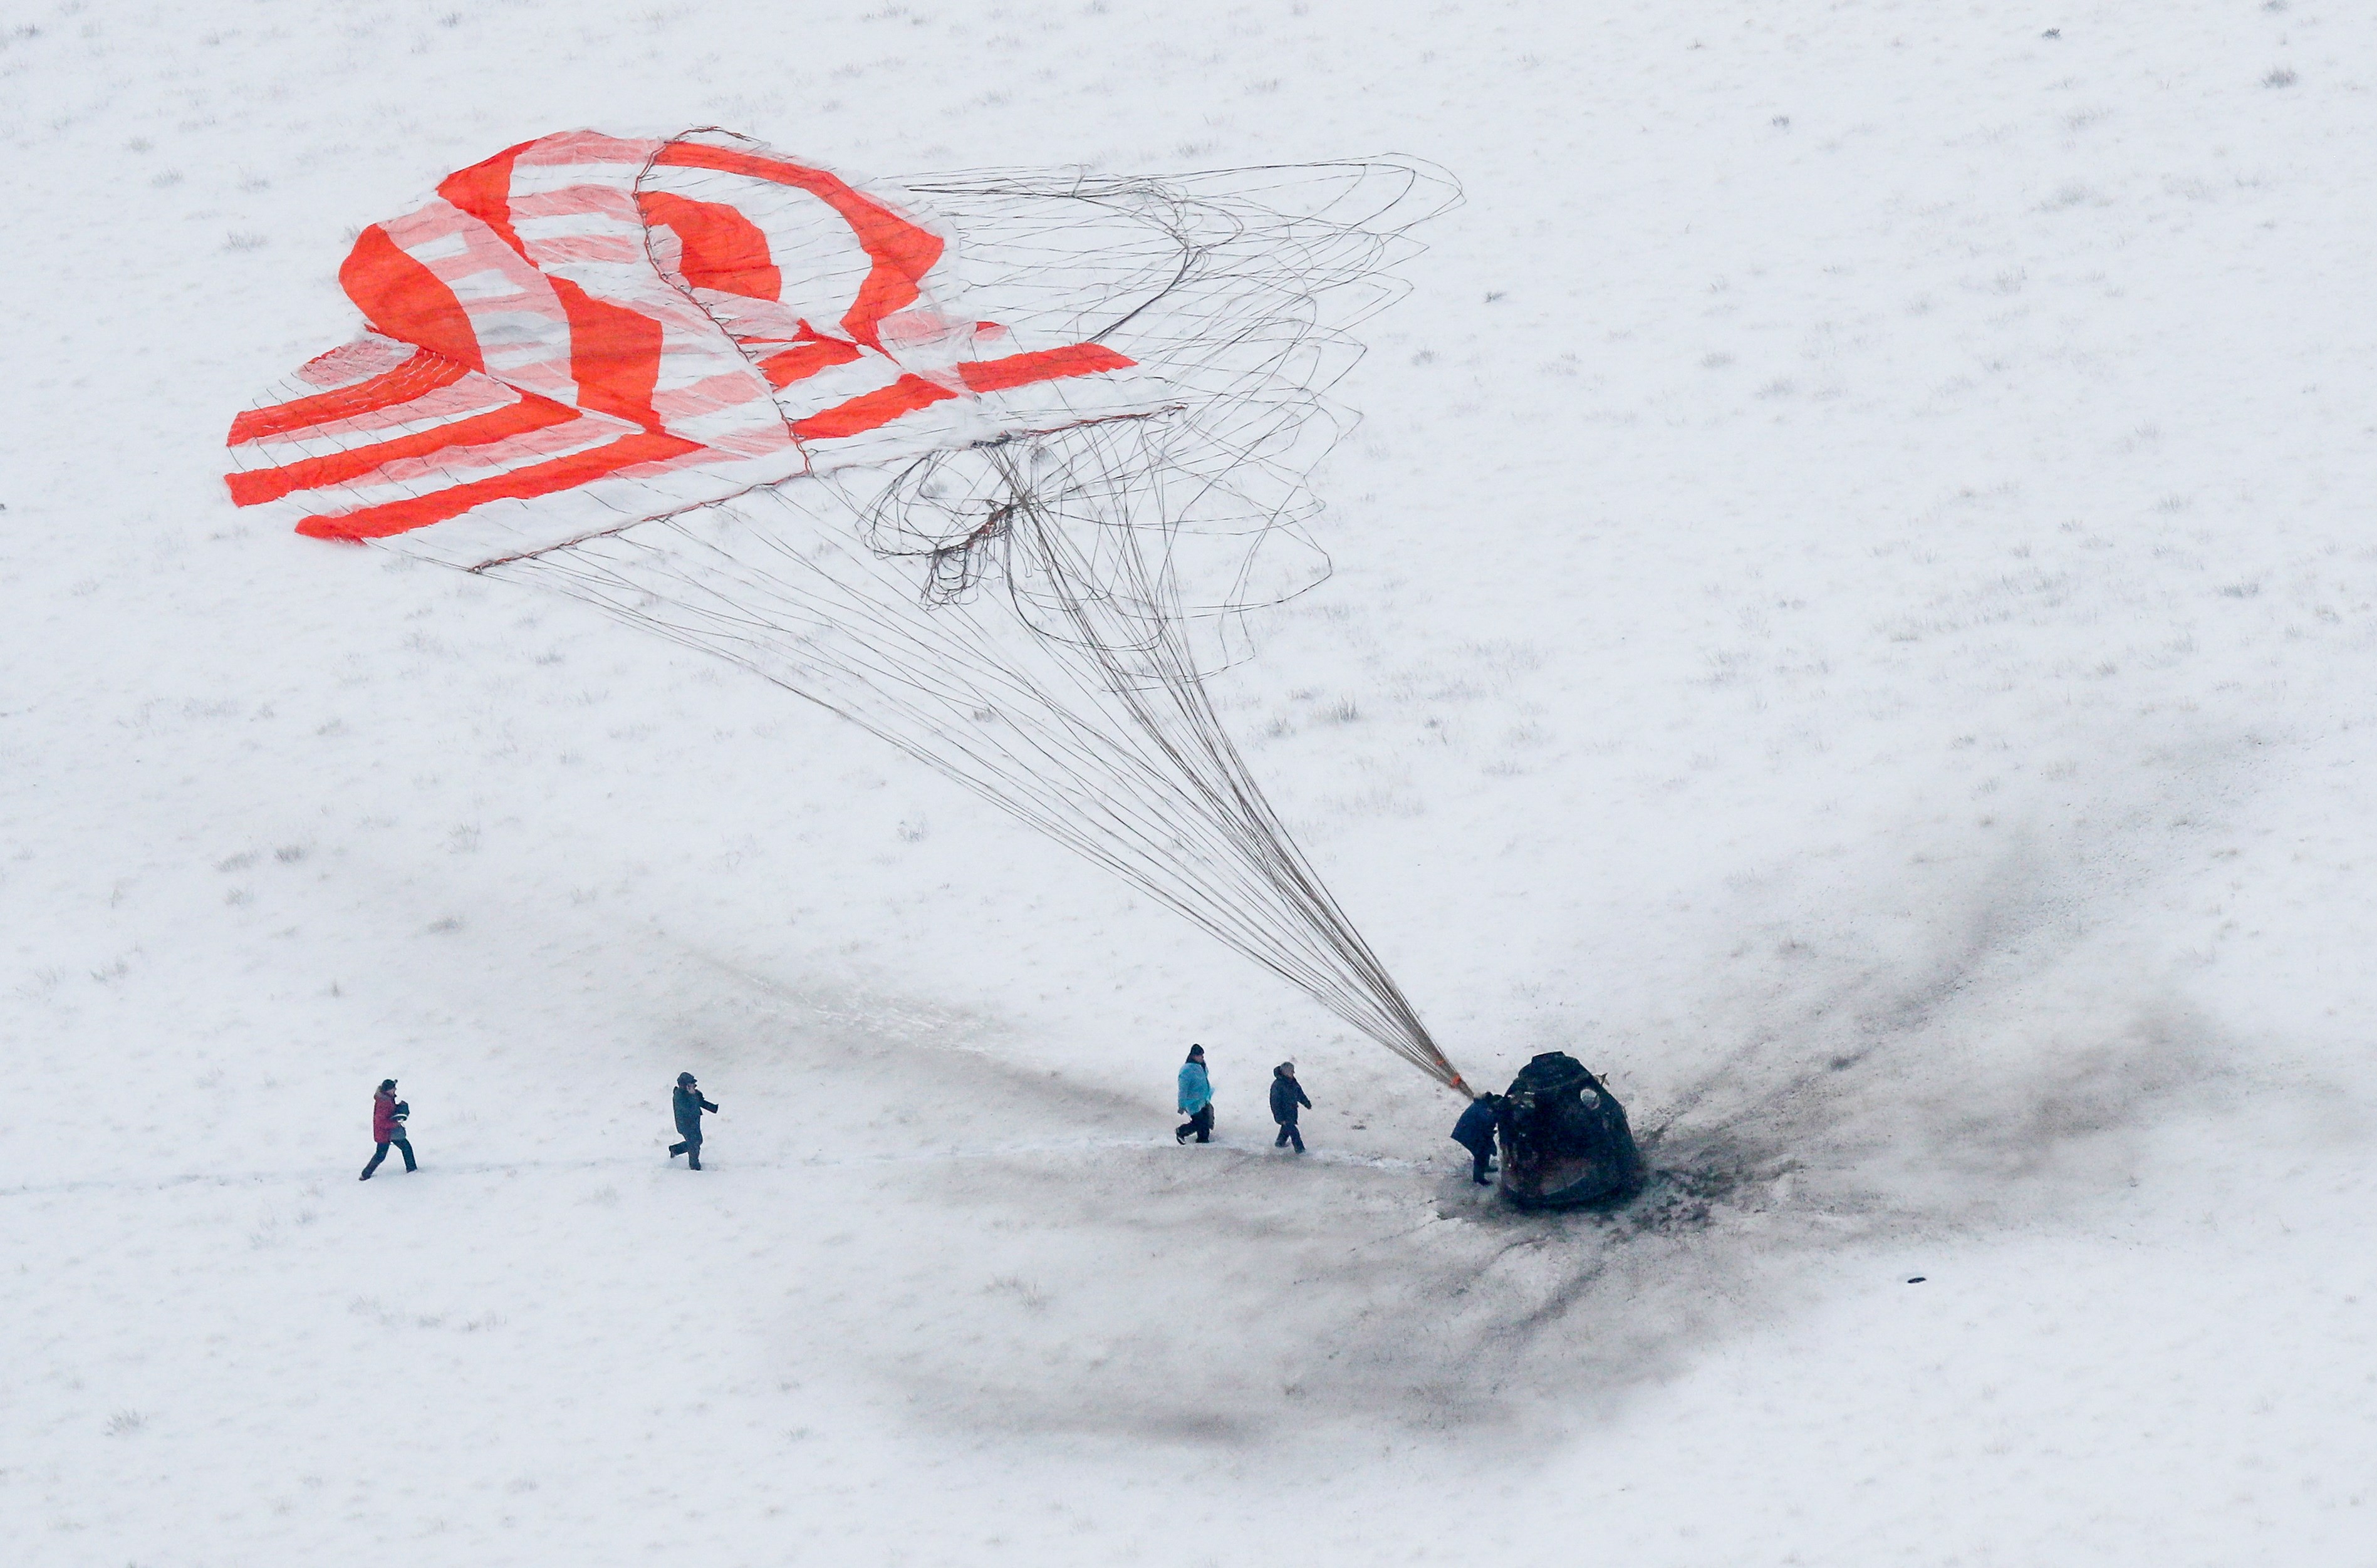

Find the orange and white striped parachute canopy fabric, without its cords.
xmin=228 ymin=131 xmax=1162 ymax=566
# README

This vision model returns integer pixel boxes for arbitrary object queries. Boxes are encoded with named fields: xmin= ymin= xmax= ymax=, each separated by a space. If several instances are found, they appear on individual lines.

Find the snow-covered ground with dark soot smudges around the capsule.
xmin=0 ymin=0 xmax=2377 ymax=1568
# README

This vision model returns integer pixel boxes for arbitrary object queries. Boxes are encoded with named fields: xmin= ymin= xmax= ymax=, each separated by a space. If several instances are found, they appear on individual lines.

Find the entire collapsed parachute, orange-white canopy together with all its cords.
xmin=228 ymin=131 xmax=1462 ymax=1088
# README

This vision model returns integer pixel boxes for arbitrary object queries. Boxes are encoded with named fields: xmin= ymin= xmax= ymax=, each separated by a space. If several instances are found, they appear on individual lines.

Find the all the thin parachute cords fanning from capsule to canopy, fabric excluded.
xmin=499 ymin=164 xmax=1464 ymax=1088
